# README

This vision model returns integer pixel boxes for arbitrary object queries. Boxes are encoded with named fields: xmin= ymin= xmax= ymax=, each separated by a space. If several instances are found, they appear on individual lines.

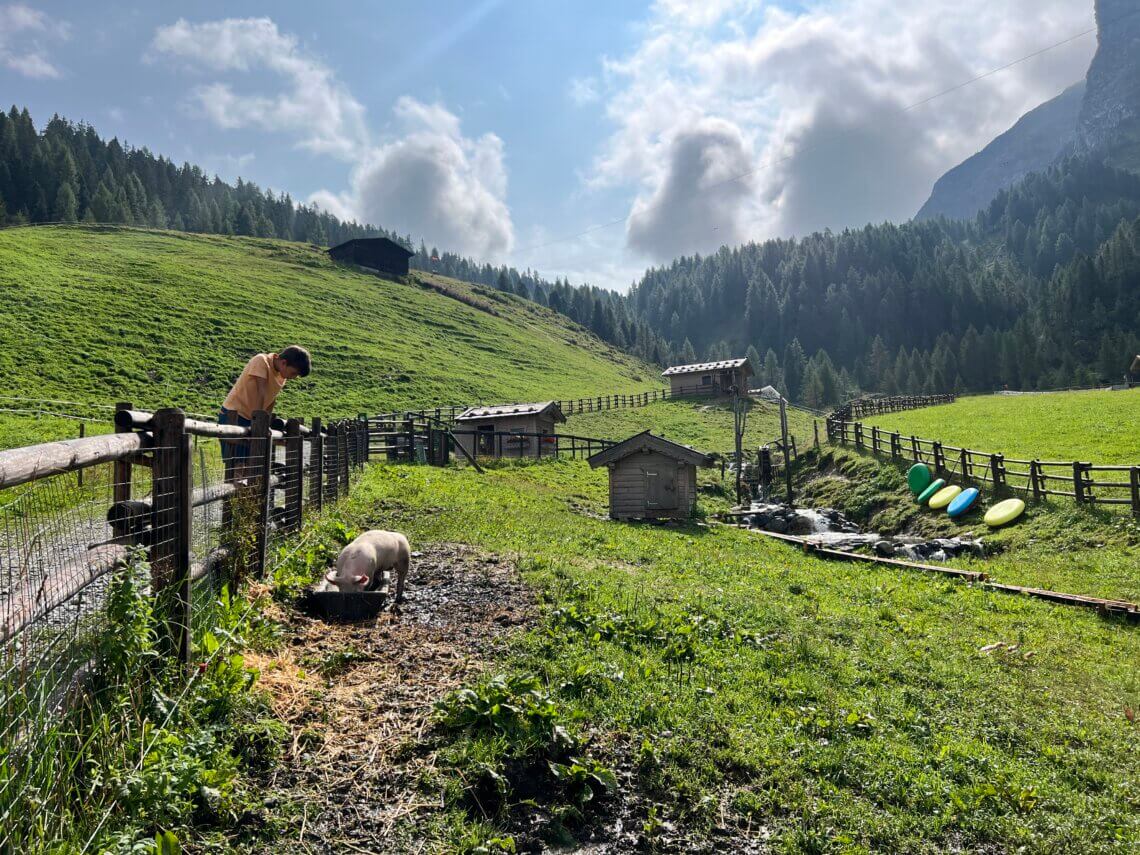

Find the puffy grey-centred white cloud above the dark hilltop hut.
xmin=310 ymin=96 xmax=514 ymax=259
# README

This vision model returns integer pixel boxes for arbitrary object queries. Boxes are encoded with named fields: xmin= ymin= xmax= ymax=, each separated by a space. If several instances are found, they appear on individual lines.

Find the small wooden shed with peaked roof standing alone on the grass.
xmin=589 ymin=431 xmax=713 ymax=520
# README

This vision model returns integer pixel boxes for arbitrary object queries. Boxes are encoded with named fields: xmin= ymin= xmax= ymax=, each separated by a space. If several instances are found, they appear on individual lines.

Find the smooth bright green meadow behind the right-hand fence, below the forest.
xmin=864 ymin=389 xmax=1140 ymax=464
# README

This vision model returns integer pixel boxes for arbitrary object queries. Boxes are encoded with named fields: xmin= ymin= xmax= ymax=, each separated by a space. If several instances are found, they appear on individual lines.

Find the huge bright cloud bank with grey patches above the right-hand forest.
xmin=588 ymin=0 xmax=1096 ymax=261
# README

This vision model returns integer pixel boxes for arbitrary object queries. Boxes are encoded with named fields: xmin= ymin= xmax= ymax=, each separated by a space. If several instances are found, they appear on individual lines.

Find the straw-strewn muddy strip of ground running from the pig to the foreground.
xmin=249 ymin=544 xmax=535 ymax=853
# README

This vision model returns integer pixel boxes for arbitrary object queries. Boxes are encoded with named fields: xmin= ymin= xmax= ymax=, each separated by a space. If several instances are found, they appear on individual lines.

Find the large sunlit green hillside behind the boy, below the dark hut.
xmin=0 ymin=227 xmax=660 ymax=443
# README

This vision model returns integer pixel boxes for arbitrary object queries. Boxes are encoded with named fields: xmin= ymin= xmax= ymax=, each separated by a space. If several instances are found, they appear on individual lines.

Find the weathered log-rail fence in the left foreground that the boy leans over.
xmin=0 ymin=404 xmax=368 ymax=662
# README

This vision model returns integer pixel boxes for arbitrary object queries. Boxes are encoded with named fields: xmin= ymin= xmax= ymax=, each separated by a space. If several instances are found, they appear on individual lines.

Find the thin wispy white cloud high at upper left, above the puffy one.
xmin=148 ymin=18 xmax=368 ymax=160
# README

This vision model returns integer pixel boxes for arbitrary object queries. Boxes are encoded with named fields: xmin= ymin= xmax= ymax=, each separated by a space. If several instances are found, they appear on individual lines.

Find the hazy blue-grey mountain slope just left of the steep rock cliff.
xmin=915 ymin=81 xmax=1085 ymax=220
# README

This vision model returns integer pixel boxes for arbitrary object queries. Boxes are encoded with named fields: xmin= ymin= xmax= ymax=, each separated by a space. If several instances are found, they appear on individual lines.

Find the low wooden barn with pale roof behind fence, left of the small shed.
xmin=453 ymin=401 xmax=567 ymax=457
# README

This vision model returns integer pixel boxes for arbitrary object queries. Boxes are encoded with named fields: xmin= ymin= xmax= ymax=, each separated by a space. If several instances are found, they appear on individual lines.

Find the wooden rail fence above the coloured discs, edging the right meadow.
xmin=827 ymin=417 xmax=1140 ymax=516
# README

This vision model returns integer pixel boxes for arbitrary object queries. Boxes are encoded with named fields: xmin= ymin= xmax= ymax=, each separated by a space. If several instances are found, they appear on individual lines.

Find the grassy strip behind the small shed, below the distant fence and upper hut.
xmin=568 ymin=398 xmax=823 ymax=451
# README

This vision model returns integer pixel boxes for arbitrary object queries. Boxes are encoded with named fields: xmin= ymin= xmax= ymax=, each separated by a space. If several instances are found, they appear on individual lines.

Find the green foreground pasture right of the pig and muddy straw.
xmin=332 ymin=461 xmax=1140 ymax=852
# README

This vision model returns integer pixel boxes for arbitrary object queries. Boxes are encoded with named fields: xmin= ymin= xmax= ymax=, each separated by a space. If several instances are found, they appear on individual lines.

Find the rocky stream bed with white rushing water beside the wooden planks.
xmin=743 ymin=503 xmax=985 ymax=562
